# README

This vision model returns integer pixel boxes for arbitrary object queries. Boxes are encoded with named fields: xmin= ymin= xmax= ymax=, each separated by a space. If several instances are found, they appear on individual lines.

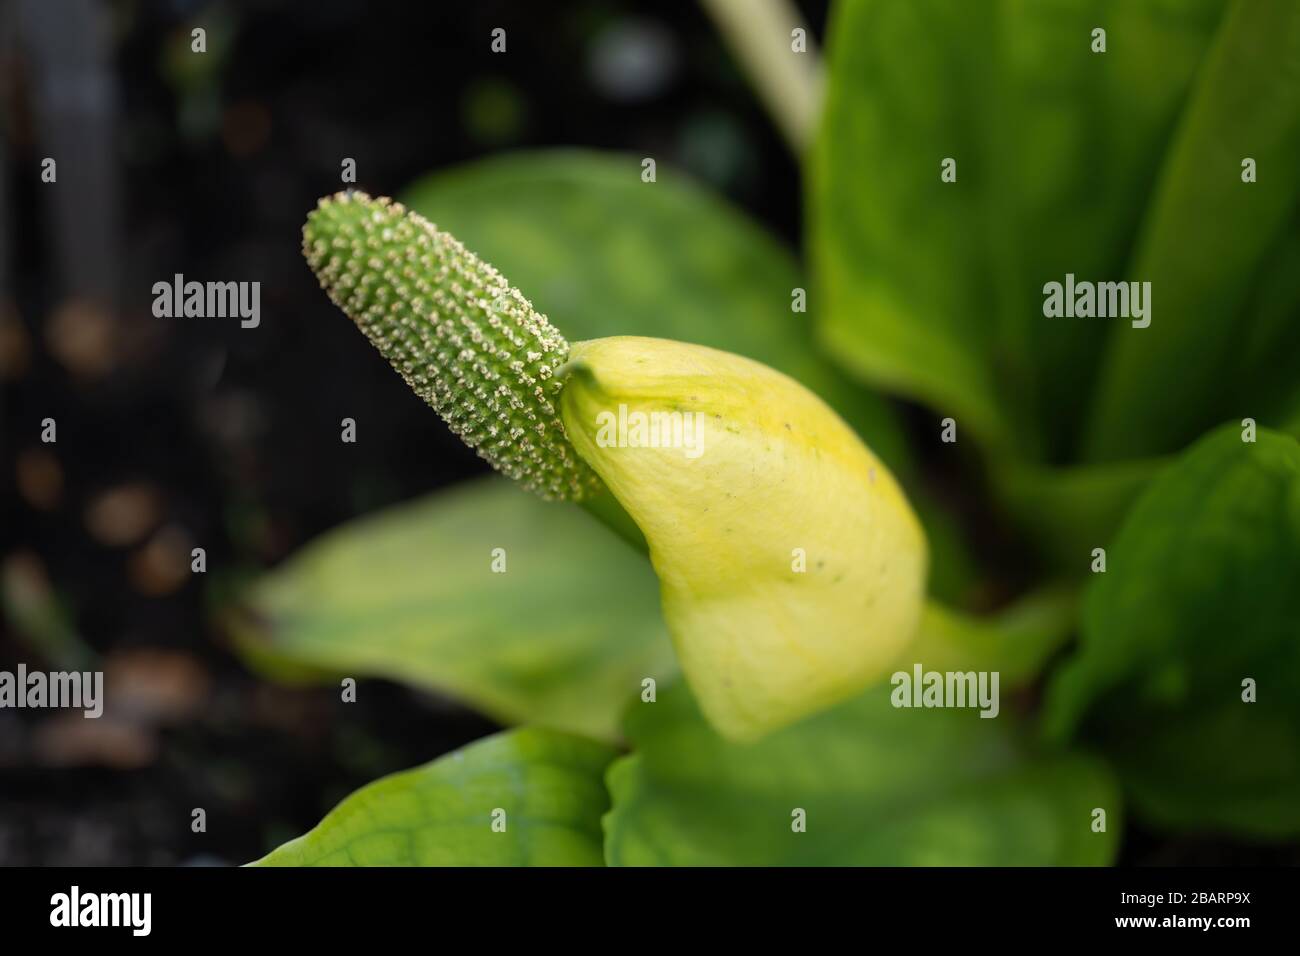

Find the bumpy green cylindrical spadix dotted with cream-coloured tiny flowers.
xmin=303 ymin=193 xmax=599 ymax=501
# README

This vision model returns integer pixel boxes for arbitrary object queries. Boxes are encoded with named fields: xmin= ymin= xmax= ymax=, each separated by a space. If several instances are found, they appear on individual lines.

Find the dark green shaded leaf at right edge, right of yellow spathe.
xmin=1047 ymin=425 xmax=1300 ymax=836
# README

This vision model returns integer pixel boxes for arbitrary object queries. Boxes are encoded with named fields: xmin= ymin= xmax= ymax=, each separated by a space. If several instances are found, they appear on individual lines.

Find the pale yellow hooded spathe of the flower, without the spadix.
xmin=559 ymin=337 xmax=927 ymax=740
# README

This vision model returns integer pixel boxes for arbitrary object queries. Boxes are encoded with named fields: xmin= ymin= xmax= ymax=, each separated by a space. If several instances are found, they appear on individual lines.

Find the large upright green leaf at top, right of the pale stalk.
xmin=809 ymin=0 xmax=1225 ymax=458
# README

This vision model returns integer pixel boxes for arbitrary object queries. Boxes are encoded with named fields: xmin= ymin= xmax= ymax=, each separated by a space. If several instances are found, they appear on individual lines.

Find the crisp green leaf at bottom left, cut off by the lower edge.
xmin=252 ymin=727 xmax=615 ymax=866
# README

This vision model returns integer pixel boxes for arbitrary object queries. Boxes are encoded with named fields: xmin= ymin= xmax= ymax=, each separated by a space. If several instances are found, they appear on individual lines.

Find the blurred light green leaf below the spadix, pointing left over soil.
xmin=229 ymin=479 xmax=676 ymax=739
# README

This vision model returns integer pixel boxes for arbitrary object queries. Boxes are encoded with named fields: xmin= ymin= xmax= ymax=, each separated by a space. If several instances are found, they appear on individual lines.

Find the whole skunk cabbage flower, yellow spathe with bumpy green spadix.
xmin=303 ymin=193 xmax=927 ymax=740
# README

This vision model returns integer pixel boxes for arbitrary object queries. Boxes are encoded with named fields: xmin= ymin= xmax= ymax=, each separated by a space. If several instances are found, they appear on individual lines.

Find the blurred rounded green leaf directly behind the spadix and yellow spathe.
xmin=403 ymin=150 xmax=906 ymax=472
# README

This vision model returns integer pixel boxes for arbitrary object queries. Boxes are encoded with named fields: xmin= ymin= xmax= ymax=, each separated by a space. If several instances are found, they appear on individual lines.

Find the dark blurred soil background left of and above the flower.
xmin=0 ymin=0 xmax=1281 ymax=865
